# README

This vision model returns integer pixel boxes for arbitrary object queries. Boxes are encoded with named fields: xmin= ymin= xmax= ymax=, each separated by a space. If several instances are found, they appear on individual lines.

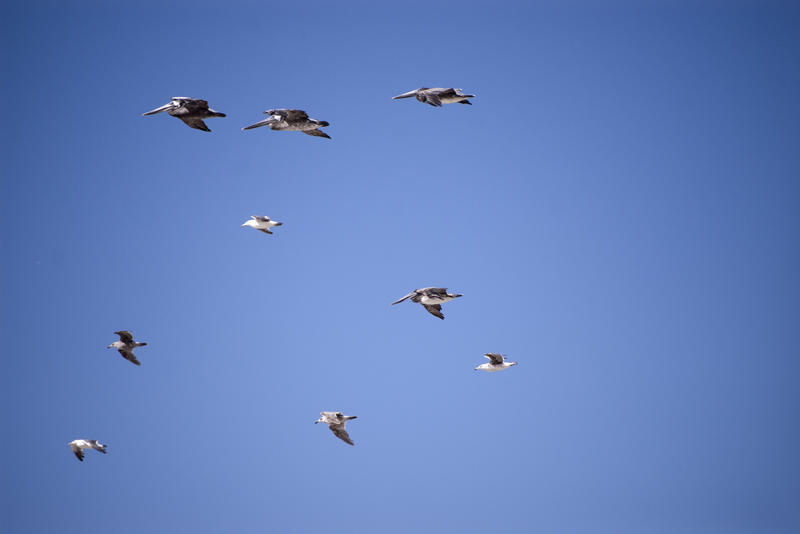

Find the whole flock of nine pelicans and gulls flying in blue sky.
xmin=69 ymin=87 xmax=517 ymax=461
